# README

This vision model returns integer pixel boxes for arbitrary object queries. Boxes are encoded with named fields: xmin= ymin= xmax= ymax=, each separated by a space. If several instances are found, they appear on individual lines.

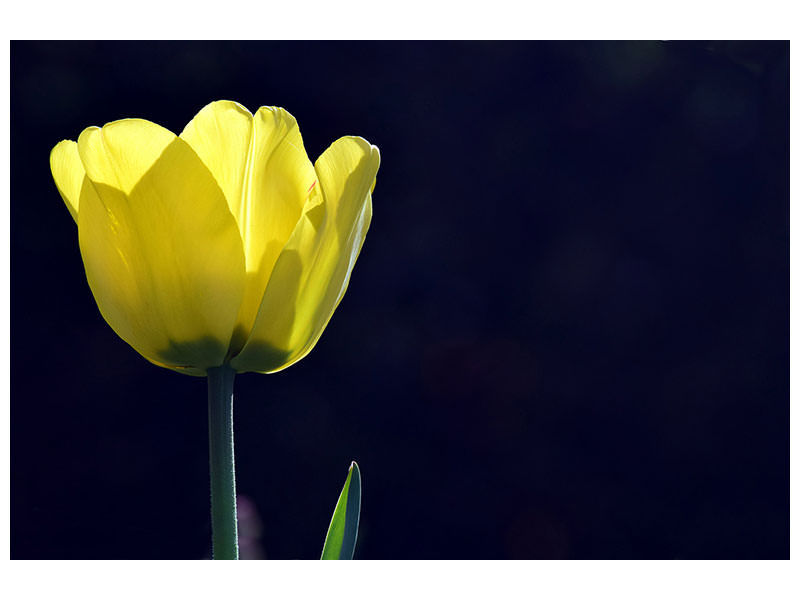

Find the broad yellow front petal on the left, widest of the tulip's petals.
xmin=78 ymin=125 xmax=245 ymax=374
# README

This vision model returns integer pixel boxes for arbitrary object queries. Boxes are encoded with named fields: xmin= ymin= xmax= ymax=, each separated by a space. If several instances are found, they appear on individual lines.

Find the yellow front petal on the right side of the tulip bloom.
xmin=231 ymin=137 xmax=380 ymax=372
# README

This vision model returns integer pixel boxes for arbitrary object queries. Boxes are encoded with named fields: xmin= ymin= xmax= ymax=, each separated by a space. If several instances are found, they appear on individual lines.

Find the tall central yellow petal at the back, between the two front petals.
xmin=181 ymin=101 xmax=316 ymax=347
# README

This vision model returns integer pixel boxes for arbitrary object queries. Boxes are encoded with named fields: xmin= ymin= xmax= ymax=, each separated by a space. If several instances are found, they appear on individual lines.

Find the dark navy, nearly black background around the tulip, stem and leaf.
xmin=10 ymin=42 xmax=789 ymax=559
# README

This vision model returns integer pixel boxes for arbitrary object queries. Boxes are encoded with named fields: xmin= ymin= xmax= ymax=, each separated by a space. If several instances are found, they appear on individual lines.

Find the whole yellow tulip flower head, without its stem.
xmin=50 ymin=101 xmax=380 ymax=376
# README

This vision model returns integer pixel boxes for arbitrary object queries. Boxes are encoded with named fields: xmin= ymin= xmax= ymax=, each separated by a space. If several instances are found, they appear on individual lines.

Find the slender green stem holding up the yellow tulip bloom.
xmin=208 ymin=365 xmax=239 ymax=560
